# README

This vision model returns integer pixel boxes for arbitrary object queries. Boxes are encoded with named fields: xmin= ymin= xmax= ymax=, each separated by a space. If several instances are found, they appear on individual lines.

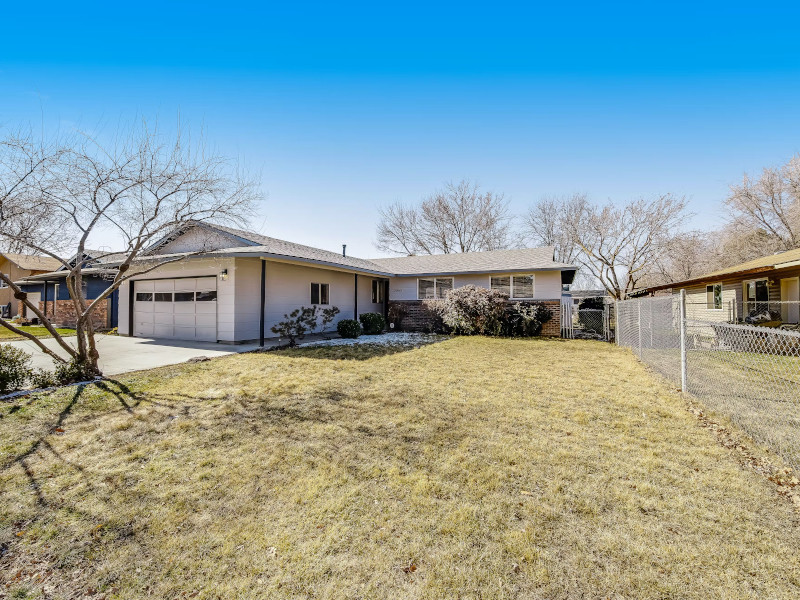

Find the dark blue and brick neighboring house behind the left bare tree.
xmin=15 ymin=250 xmax=119 ymax=329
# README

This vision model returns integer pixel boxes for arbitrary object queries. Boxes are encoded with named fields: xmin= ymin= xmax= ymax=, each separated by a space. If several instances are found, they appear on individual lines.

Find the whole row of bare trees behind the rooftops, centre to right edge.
xmin=376 ymin=155 xmax=800 ymax=298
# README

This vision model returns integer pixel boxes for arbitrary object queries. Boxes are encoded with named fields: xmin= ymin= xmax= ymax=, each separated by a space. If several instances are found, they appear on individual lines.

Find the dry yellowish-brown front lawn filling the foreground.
xmin=0 ymin=338 xmax=800 ymax=599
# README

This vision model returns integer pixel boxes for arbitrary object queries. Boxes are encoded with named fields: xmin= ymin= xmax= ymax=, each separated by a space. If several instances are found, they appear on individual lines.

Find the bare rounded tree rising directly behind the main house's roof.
xmin=376 ymin=180 xmax=515 ymax=255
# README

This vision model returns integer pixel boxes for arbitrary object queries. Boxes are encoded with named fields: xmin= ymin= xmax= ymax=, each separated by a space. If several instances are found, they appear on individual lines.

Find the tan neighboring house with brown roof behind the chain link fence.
xmin=639 ymin=248 xmax=800 ymax=323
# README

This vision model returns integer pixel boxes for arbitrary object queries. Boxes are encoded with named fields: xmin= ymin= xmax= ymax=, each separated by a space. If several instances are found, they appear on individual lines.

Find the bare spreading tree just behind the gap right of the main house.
xmin=528 ymin=194 xmax=686 ymax=299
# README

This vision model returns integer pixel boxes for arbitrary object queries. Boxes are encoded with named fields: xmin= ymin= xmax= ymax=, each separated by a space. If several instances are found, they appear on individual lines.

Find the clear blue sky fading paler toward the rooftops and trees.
xmin=0 ymin=1 xmax=800 ymax=257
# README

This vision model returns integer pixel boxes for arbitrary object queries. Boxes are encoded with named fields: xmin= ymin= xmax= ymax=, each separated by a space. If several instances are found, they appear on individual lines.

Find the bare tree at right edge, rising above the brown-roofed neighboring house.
xmin=725 ymin=155 xmax=800 ymax=250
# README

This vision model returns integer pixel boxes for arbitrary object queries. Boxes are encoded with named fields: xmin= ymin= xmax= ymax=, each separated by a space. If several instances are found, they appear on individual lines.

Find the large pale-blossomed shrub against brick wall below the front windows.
xmin=425 ymin=285 xmax=550 ymax=337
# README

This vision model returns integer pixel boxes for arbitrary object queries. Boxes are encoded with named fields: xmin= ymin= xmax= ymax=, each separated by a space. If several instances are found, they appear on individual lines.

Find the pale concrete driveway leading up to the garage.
xmin=3 ymin=335 xmax=262 ymax=375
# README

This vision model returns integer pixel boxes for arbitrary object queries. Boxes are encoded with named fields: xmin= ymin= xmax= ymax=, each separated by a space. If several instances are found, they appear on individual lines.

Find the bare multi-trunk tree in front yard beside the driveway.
xmin=0 ymin=124 xmax=260 ymax=374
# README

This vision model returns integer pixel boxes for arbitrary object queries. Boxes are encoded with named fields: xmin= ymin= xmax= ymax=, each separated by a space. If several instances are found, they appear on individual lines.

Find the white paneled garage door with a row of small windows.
xmin=133 ymin=277 xmax=217 ymax=342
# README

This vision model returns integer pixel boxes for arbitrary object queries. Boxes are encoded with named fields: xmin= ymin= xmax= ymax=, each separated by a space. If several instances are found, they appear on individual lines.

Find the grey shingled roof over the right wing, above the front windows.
xmin=372 ymin=246 xmax=578 ymax=276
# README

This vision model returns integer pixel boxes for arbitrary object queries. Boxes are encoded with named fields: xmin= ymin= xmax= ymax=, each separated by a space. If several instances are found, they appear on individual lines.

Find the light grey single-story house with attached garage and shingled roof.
xmin=108 ymin=223 xmax=577 ymax=343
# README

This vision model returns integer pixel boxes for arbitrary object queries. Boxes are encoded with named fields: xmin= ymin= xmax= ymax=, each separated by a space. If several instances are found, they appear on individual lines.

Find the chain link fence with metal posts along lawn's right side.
xmin=616 ymin=296 xmax=800 ymax=469
